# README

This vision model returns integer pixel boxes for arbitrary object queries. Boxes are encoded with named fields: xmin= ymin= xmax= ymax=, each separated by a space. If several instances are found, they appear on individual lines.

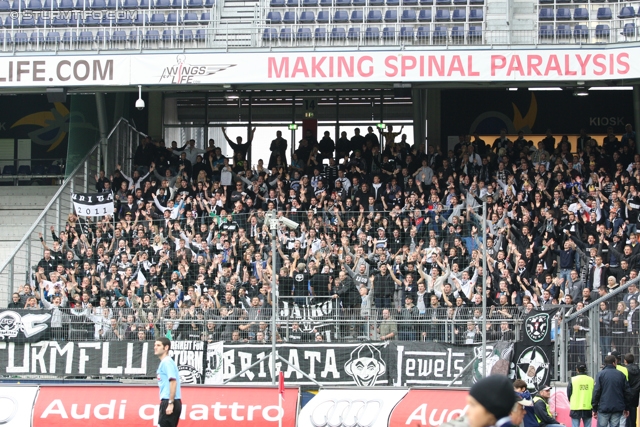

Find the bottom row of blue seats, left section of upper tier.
xmin=0 ymin=29 xmax=207 ymax=45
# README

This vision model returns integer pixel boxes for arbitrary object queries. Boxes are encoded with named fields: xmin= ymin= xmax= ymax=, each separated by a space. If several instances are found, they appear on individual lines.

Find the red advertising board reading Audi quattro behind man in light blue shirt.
xmin=31 ymin=386 xmax=299 ymax=427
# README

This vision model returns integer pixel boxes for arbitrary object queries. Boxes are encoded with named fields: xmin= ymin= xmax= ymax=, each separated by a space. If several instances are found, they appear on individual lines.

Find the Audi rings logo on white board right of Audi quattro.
xmin=309 ymin=399 xmax=382 ymax=427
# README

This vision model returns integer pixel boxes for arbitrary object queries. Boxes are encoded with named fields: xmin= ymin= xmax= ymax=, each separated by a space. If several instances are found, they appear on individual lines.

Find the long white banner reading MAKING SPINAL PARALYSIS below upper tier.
xmin=0 ymin=45 xmax=640 ymax=88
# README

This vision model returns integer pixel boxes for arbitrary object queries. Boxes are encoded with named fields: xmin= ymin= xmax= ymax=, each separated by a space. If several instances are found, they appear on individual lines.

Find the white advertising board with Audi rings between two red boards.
xmin=297 ymin=389 xmax=408 ymax=427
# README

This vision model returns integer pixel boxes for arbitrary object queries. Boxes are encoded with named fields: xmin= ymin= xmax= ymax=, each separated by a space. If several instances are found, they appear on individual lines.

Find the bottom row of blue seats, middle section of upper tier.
xmin=262 ymin=26 xmax=482 ymax=41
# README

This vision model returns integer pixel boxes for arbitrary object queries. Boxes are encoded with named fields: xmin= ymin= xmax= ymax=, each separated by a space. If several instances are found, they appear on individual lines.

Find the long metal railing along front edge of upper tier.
xmin=0 ymin=22 xmax=640 ymax=54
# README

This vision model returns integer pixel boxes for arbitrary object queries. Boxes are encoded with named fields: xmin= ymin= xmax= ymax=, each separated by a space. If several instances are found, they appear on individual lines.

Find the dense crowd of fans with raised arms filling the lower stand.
xmin=10 ymin=125 xmax=640 ymax=354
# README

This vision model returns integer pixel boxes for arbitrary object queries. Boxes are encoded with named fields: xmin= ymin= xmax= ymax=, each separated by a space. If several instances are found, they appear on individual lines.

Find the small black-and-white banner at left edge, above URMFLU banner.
xmin=0 ymin=309 xmax=51 ymax=342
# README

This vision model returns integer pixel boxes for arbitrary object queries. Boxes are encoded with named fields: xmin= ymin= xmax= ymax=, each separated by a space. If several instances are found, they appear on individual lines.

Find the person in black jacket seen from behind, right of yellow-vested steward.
xmin=591 ymin=355 xmax=631 ymax=427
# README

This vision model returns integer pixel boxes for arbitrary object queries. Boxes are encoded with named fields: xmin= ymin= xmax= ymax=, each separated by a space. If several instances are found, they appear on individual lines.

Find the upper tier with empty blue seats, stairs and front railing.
xmin=0 ymin=0 xmax=640 ymax=52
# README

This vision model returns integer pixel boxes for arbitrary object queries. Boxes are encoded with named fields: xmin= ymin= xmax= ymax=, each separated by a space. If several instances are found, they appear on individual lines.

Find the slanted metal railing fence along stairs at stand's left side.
xmin=0 ymin=118 xmax=144 ymax=307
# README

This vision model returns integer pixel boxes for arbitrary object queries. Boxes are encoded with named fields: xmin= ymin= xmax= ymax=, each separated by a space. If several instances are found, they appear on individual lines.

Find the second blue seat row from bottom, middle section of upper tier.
xmin=267 ymin=9 xmax=483 ymax=24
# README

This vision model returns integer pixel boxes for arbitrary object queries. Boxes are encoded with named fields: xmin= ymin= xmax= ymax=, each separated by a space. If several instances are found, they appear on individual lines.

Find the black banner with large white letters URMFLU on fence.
xmin=0 ymin=341 xmax=159 ymax=378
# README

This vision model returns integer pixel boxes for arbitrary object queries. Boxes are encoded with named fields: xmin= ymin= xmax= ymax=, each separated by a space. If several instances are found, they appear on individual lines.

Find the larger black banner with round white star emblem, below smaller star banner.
xmin=513 ymin=342 xmax=553 ymax=392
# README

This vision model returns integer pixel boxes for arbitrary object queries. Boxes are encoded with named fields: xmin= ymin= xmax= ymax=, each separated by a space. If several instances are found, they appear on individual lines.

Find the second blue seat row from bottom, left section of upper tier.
xmin=0 ymin=12 xmax=211 ymax=28
